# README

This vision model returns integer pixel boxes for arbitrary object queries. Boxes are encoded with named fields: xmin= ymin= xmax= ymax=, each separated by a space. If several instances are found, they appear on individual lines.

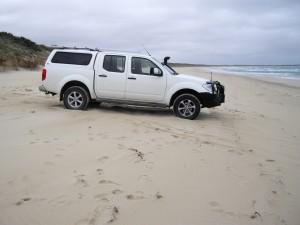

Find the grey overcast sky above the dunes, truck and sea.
xmin=0 ymin=0 xmax=300 ymax=64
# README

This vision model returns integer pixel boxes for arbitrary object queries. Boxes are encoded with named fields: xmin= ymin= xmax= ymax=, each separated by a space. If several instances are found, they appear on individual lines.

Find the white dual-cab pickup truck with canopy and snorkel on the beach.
xmin=39 ymin=48 xmax=225 ymax=119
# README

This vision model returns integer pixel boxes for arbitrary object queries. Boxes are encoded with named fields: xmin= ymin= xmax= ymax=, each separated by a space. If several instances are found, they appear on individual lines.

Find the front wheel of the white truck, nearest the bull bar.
xmin=173 ymin=94 xmax=201 ymax=120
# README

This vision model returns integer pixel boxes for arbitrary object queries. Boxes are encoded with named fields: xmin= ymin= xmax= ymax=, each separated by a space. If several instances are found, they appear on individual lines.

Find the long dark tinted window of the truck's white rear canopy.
xmin=51 ymin=52 xmax=92 ymax=66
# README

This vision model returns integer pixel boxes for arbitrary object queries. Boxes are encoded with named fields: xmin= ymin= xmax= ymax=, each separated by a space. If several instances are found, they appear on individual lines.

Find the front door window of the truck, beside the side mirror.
xmin=131 ymin=57 xmax=162 ymax=75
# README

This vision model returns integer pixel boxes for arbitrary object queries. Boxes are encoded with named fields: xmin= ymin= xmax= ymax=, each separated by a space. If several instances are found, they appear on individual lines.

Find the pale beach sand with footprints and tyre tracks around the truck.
xmin=0 ymin=68 xmax=300 ymax=225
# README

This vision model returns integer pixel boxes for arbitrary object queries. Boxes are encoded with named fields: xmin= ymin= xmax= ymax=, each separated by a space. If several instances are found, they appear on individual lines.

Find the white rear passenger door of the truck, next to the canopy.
xmin=95 ymin=54 xmax=127 ymax=99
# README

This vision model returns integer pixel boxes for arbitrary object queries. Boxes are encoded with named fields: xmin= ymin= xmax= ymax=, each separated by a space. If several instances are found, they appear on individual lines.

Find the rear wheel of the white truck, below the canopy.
xmin=63 ymin=86 xmax=90 ymax=110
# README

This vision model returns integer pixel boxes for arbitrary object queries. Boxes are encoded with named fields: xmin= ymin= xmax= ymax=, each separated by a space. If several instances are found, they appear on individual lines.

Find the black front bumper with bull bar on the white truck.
xmin=200 ymin=81 xmax=225 ymax=108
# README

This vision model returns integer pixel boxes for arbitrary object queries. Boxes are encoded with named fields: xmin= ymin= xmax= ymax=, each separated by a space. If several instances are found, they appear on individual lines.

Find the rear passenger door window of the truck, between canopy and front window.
xmin=103 ymin=55 xmax=125 ymax=73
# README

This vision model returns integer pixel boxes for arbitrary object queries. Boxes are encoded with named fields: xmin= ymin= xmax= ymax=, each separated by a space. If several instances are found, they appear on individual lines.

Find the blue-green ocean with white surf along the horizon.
xmin=210 ymin=65 xmax=300 ymax=80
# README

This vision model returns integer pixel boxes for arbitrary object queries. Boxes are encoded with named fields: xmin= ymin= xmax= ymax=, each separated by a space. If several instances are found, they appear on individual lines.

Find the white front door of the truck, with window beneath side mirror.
xmin=126 ymin=57 xmax=167 ymax=103
